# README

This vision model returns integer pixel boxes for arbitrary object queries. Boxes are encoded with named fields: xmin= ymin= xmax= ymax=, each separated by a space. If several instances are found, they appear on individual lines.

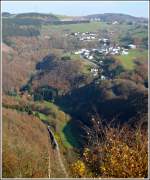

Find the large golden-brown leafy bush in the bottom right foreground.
xmin=83 ymin=126 xmax=148 ymax=178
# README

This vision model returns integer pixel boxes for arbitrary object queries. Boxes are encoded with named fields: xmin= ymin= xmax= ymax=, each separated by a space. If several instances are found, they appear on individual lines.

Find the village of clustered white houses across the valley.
xmin=72 ymin=32 xmax=136 ymax=80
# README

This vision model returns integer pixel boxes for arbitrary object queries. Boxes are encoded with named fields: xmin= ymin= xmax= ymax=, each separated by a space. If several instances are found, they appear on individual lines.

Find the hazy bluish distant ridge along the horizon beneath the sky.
xmin=2 ymin=12 xmax=148 ymax=23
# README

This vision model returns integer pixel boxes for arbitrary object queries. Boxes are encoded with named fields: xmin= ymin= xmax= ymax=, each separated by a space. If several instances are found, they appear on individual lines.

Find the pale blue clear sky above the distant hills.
xmin=2 ymin=1 xmax=148 ymax=17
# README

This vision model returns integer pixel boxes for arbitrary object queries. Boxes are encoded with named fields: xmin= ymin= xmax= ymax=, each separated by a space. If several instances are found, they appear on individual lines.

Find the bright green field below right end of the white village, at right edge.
xmin=115 ymin=49 xmax=148 ymax=70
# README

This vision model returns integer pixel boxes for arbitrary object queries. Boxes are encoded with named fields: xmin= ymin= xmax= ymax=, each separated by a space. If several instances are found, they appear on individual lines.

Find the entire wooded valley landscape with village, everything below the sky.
xmin=2 ymin=12 xmax=149 ymax=178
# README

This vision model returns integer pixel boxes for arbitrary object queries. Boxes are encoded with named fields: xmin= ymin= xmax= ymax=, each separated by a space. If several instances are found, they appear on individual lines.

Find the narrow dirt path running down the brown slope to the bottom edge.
xmin=47 ymin=126 xmax=68 ymax=178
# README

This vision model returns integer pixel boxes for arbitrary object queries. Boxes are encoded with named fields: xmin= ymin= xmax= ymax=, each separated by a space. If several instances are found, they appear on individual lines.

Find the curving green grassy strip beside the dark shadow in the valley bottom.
xmin=33 ymin=101 xmax=77 ymax=148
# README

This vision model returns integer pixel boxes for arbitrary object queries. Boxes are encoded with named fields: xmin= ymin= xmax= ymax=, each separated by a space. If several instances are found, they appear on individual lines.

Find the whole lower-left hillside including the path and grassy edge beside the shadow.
xmin=3 ymin=96 xmax=76 ymax=178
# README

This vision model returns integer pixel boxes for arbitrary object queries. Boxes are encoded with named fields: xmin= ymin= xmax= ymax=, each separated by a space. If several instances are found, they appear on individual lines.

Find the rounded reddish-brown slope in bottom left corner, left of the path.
xmin=3 ymin=108 xmax=51 ymax=178
